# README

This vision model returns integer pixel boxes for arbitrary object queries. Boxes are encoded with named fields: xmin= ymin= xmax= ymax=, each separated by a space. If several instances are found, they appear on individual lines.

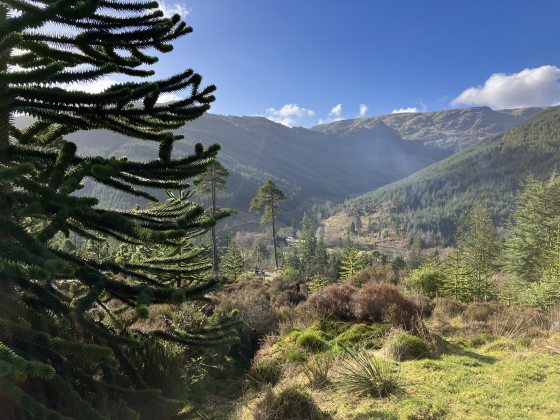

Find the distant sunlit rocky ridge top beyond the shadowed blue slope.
xmin=313 ymin=107 xmax=542 ymax=150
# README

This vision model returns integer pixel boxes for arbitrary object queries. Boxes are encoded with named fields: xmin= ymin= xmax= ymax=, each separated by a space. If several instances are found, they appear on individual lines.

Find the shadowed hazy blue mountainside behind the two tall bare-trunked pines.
xmin=17 ymin=114 xmax=450 ymax=229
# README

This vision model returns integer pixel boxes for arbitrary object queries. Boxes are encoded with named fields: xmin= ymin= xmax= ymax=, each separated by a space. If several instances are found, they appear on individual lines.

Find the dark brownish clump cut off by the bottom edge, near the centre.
xmin=252 ymin=386 xmax=326 ymax=420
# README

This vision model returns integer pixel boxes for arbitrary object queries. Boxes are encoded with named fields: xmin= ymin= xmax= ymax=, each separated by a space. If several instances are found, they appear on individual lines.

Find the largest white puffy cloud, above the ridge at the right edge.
xmin=451 ymin=66 xmax=560 ymax=109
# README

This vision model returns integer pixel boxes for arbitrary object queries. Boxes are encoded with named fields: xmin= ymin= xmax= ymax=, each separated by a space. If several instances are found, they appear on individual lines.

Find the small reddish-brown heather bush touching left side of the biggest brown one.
xmin=307 ymin=284 xmax=356 ymax=320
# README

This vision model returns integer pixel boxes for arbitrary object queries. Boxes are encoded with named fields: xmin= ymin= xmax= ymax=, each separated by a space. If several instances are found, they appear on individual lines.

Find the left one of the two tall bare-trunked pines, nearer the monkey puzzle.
xmin=194 ymin=160 xmax=229 ymax=275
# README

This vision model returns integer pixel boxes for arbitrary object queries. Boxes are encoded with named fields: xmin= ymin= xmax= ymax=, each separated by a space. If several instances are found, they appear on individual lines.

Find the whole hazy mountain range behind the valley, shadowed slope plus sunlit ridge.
xmin=16 ymin=107 xmax=541 ymax=229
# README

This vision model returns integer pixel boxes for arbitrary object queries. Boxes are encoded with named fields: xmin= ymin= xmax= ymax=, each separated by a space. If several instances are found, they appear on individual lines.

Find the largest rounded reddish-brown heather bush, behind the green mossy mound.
xmin=353 ymin=283 xmax=421 ymax=329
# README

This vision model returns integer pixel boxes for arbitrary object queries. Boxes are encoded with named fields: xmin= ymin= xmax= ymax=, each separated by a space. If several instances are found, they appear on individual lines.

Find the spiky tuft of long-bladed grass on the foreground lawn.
xmin=338 ymin=349 xmax=400 ymax=398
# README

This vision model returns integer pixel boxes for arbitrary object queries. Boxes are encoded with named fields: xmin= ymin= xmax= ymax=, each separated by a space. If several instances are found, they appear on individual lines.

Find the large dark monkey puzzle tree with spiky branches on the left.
xmin=0 ymin=0 xmax=238 ymax=419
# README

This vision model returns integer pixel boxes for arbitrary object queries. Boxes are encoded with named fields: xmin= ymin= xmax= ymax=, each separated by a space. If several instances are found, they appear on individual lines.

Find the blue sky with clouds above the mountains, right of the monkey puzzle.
xmin=153 ymin=0 xmax=560 ymax=126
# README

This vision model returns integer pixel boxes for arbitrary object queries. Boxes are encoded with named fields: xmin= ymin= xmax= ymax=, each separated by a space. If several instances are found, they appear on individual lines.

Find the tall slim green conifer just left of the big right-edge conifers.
xmin=457 ymin=203 xmax=498 ymax=301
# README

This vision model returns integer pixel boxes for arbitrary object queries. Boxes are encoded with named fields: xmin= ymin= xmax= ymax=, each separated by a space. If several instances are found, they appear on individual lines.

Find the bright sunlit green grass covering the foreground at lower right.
xmin=235 ymin=324 xmax=560 ymax=420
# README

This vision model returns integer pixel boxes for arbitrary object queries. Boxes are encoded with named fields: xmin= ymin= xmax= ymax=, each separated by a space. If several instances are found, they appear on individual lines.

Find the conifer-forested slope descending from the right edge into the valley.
xmin=325 ymin=107 xmax=560 ymax=243
